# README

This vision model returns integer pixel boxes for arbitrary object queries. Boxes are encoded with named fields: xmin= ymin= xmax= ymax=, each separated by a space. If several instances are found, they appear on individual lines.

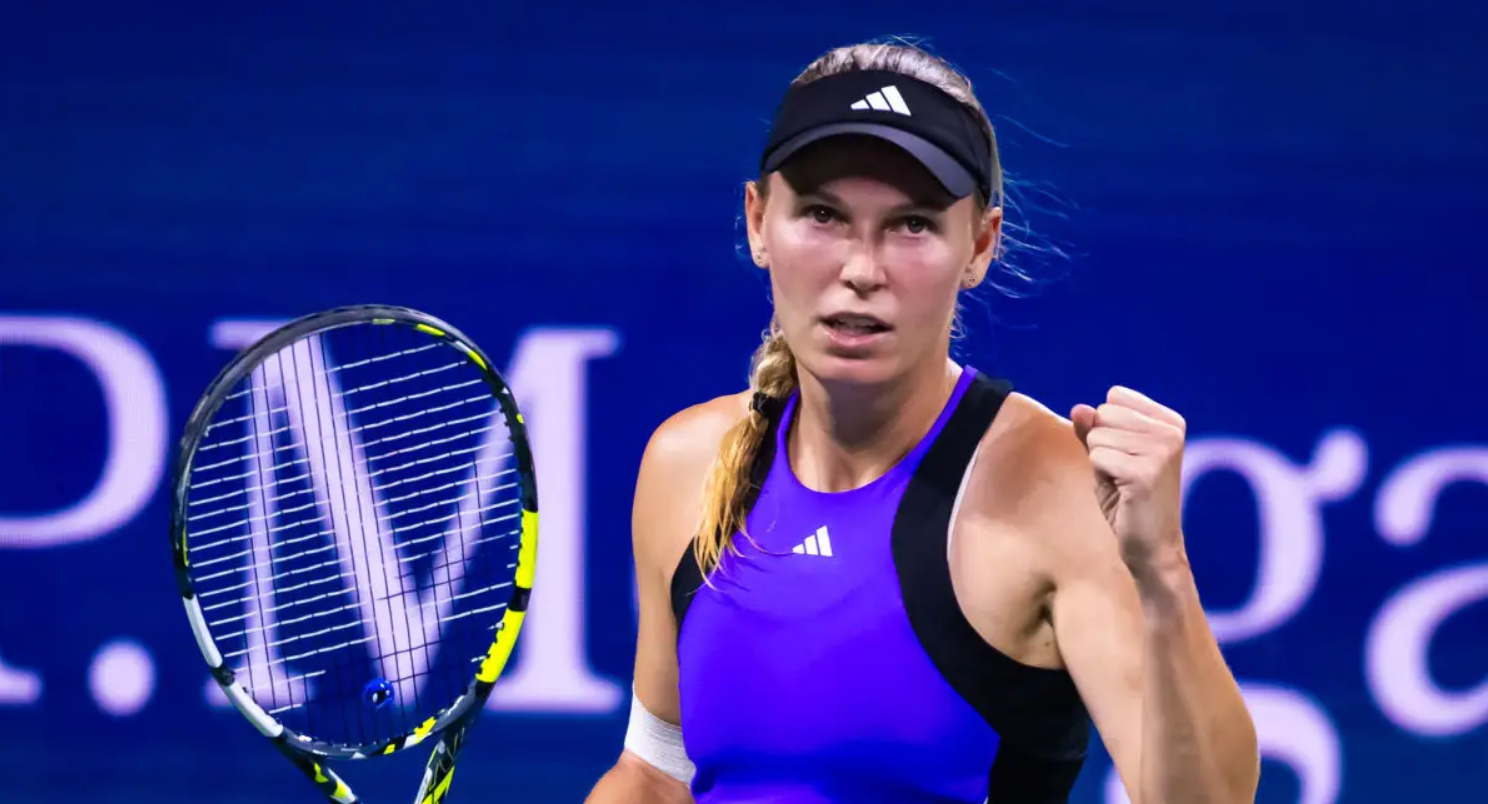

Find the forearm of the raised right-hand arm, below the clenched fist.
xmin=1132 ymin=554 xmax=1259 ymax=804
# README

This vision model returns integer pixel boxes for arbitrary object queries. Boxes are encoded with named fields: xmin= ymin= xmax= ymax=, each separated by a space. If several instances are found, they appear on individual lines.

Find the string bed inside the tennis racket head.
xmin=187 ymin=328 xmax=521 ymax=744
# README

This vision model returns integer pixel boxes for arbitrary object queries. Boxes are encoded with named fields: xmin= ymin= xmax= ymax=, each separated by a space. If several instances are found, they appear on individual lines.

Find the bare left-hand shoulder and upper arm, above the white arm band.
xmin=631 ymin=396 xmax=744 ymax=725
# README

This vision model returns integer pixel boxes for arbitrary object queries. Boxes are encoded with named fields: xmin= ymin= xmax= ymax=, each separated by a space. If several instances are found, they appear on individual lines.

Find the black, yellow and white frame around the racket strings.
xmin=171 ymin=305 xmax=537 ymax=768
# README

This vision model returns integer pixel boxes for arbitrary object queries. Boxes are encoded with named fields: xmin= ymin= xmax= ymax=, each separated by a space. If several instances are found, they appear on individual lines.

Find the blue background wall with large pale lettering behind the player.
xmin=0 ymin=0 xmax=1488 ymax=804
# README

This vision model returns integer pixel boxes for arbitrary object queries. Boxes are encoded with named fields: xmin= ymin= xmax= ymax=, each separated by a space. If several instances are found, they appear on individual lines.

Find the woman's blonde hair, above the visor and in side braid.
xmin=693 ymin=42 xmax=1003 ymax=581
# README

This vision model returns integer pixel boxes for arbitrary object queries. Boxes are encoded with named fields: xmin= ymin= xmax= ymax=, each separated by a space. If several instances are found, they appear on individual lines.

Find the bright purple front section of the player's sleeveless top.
xmin=677 ymin=368 xmax=998 ymax=804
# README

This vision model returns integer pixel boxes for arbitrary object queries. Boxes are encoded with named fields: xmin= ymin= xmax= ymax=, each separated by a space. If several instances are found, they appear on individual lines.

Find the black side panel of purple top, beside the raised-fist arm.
xmin=893 ymin=375 xmax=1089 ymax=804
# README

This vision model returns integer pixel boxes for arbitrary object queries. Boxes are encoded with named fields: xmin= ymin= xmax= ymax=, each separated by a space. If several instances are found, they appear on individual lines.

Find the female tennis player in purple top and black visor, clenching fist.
xmin=589 ymin=45 xmax=1259 ymax=804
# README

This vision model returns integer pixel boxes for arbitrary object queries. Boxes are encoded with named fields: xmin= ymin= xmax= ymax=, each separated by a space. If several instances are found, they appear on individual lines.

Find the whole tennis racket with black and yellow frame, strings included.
xmin=171 ymin=305 xmax=537 ymax=804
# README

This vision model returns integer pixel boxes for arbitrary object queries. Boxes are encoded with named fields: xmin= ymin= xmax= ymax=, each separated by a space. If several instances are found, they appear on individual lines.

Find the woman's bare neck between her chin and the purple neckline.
xmin=786 ymin=360 xmax=960 ymax=491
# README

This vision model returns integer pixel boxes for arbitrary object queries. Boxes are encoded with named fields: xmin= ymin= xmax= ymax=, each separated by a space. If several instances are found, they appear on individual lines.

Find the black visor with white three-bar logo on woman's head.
xmin=760 ymin=70 xmax=992 ymax=201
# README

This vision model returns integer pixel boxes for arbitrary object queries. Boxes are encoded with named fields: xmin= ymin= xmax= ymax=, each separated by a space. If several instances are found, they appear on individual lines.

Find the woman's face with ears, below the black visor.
xmin=745 ymin=137 xmax=1001 ymax=384
